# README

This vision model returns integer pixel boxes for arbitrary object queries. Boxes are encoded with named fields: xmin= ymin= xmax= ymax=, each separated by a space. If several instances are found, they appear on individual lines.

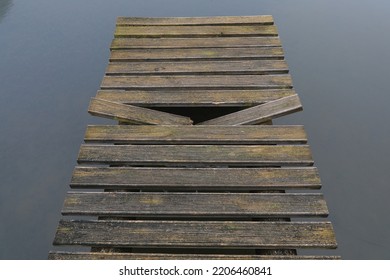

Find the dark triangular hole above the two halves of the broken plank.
xmin=150 ymin=107 xmax=246 ymax=124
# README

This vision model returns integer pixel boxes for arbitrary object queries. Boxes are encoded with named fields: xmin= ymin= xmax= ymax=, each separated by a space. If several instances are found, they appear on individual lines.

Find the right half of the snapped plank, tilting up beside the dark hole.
xmin=199 ymin=95 xmax=302 ymax=125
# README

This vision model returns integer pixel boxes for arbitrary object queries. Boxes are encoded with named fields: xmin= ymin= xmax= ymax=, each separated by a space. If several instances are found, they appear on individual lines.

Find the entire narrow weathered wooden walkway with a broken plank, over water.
xmin=49 ymin=16 xmax=337 ymax=259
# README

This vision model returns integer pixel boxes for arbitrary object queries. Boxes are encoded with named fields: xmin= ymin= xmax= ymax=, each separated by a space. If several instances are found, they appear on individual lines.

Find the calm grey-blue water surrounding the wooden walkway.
xmin=0 ymin=0 xmax=390 ymax=259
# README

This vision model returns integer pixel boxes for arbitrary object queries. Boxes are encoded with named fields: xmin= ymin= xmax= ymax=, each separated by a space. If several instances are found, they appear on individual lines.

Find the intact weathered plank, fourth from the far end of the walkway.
xmin=110 ymin=47 xmax=284 ymax=62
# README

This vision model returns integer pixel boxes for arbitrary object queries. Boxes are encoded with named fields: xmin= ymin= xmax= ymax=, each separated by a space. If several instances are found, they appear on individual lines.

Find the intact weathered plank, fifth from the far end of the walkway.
xmin=106 ymin=60 xmax=288 ymax=75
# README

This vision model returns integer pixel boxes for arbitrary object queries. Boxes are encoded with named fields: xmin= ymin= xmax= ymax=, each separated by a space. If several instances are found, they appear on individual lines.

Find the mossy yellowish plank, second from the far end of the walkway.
xmin=114 ymin=25 xmax=278 ymax=38
